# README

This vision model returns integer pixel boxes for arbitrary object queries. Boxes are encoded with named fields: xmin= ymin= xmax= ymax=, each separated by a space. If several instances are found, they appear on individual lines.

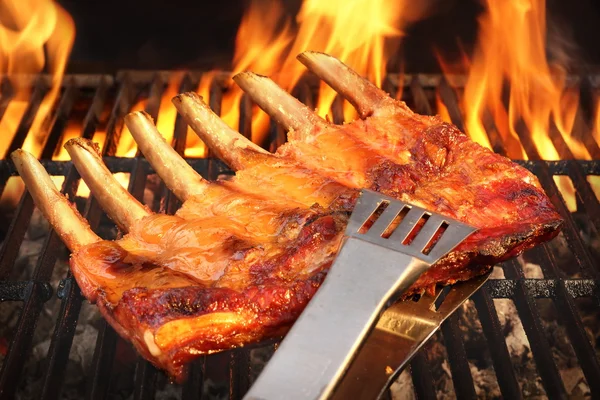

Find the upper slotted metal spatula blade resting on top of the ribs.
xmin=244 ymin=190 xmax=475 ymax=400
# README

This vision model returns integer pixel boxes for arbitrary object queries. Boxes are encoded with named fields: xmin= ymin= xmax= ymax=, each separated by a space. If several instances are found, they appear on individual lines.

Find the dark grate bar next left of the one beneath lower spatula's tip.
xmin=442 ymin=313 xmax=477 ymax=399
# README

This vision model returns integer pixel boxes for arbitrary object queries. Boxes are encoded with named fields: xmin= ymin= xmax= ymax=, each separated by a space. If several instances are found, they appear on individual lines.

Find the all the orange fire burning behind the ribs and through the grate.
xmin=0 ymin=0 xmax=600 ymax=209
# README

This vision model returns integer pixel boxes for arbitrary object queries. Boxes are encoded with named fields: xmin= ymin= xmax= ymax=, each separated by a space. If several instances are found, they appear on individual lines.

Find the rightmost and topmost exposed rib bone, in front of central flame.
xmin=298 ymin=51 xmax=393 ymax=118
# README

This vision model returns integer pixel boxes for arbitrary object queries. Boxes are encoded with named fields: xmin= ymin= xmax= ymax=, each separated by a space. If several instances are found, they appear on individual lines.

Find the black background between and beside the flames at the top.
xmin=58 ymin=0 xmax=600 ymax=73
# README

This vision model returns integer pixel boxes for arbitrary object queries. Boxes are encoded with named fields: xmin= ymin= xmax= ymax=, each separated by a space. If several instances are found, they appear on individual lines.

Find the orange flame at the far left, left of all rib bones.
xmin=0 ymin=0 xmax=75 ymax=204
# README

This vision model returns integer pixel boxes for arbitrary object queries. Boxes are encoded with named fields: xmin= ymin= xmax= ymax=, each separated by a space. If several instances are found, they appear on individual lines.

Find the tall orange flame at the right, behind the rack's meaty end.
xmin=442 ymin=0 xmax=590 ymax=160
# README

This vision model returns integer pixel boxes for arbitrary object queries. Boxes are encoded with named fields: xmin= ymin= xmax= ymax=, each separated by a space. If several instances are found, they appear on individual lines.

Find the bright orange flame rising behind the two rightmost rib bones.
xmin=199 ymin=0 xmax=429 ymax=142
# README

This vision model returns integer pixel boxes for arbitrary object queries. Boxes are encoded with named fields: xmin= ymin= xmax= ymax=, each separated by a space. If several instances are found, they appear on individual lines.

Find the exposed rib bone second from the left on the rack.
xmin=65 ymin=138 xmax=151 ymax=232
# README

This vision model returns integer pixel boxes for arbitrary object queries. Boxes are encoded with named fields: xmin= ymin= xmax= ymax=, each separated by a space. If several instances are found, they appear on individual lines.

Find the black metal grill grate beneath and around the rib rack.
xmin=0 ymin=72 xmax=600 ymax=399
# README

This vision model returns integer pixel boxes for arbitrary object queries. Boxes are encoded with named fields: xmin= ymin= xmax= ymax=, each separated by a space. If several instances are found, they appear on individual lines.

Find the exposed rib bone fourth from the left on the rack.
xmin=173 ymin=92 xmax=273 ymax=170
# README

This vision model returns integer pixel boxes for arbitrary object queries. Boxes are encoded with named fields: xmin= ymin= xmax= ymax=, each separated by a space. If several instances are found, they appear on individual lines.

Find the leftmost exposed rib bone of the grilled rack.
xmin=11 ymin=149 xmax=101 ymax=252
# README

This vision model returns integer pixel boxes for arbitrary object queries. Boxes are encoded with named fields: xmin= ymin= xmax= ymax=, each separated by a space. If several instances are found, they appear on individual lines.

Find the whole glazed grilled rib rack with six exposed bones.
xmin=13 ymin=52 xmax=562 ymax=379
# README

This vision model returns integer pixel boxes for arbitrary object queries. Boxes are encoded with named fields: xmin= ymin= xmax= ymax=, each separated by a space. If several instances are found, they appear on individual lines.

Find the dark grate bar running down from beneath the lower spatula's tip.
xmin=472 ymin=287 xmax=523 ymax=399
